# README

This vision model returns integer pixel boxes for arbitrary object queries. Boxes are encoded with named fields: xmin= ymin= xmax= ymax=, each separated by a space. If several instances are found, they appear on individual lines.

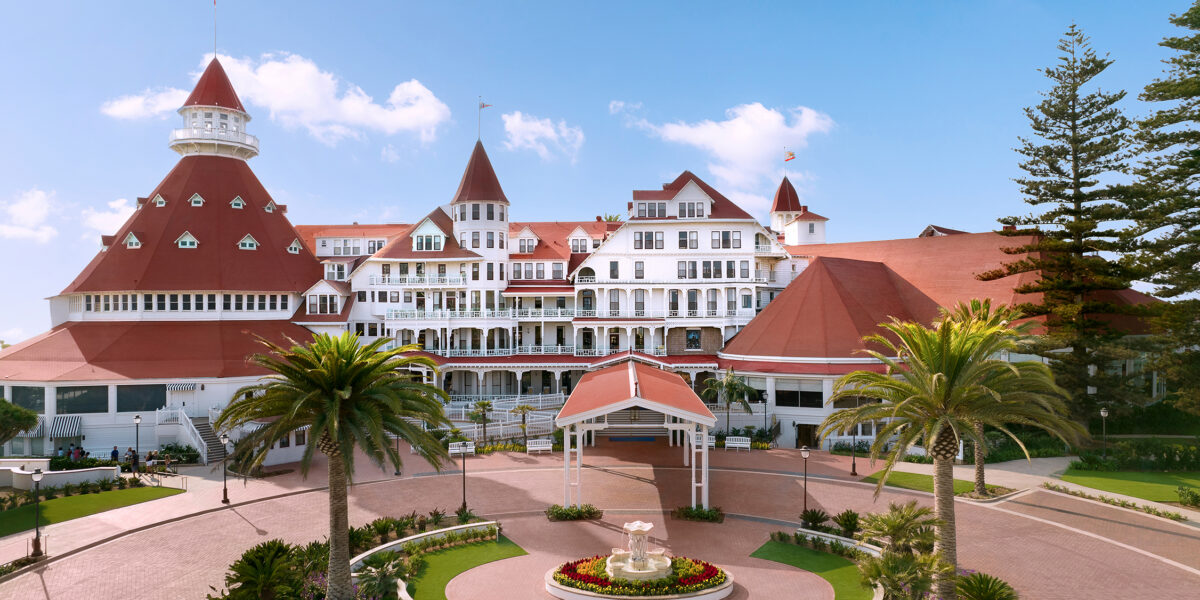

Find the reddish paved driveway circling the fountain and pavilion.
xmin=0 ymin=442 xmax=1200 ymax=600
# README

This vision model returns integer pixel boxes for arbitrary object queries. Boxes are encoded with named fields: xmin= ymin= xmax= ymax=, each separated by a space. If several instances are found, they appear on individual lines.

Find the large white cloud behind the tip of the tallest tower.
xmin=101 ymin=53 xmax=450 ymax=145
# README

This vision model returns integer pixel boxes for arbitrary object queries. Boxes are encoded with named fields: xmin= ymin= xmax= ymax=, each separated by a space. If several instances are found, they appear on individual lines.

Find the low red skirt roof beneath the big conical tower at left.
xmin=0 ymin=320 xmax=312 ymax=382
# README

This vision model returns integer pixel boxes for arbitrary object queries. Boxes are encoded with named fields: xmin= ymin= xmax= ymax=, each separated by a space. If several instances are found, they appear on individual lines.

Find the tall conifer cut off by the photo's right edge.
xmin=1127 ymin=1 xmax=1200 ymax=413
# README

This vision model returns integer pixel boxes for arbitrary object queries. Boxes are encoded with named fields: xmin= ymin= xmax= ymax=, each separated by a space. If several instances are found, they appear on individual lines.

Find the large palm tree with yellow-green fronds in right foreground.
xmin=820 ymin=304 xmax=1085 ymax=600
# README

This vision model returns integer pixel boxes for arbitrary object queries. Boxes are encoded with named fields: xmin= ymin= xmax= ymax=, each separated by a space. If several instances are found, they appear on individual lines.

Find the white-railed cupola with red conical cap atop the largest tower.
xmin=170 ymin=56 xmax=258 ymax=160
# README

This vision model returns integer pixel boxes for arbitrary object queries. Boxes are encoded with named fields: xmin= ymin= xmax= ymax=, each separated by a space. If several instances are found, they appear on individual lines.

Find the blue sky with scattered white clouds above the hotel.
xmin=0 ymin=0 xmax=1187 ymax=342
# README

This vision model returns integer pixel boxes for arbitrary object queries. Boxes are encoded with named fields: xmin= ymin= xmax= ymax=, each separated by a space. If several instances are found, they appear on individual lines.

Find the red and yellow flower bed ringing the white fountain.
xmin=553 ymin=554 xmax=728 ymax=596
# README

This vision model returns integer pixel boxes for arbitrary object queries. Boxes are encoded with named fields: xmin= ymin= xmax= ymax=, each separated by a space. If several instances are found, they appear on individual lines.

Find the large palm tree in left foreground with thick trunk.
xmin=215 ymin=332 xmax=449 ymax=600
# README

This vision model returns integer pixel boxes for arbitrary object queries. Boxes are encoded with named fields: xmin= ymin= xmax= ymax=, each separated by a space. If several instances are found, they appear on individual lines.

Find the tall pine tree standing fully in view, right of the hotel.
xmin=980 ymin=25 xmax=1148 ymax=416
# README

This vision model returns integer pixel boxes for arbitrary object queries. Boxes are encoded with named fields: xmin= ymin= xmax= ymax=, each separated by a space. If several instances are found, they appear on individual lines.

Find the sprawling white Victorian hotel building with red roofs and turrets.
xmin=0 ymin=60 xmax=1145 ymax=458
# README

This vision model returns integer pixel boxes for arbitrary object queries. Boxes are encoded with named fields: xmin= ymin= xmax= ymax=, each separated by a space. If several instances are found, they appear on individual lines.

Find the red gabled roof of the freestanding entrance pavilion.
xmin=554 ymin=360 xmax=716 ymax=427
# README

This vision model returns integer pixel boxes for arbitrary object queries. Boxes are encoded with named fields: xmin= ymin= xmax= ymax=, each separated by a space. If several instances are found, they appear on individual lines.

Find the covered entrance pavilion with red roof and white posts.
xmin=554 ymin=360 xmax=716 ymax=508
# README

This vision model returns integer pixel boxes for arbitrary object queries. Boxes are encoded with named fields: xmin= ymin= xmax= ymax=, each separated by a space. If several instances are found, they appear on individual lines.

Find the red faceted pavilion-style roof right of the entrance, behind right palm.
xmin=720 ymin=258 xmax=938 ymax=359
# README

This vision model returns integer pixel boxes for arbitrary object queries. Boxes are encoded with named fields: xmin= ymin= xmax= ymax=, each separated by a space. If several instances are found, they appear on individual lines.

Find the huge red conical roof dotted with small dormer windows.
xmin=62 ymin=155 xmax=323 ymax=294
